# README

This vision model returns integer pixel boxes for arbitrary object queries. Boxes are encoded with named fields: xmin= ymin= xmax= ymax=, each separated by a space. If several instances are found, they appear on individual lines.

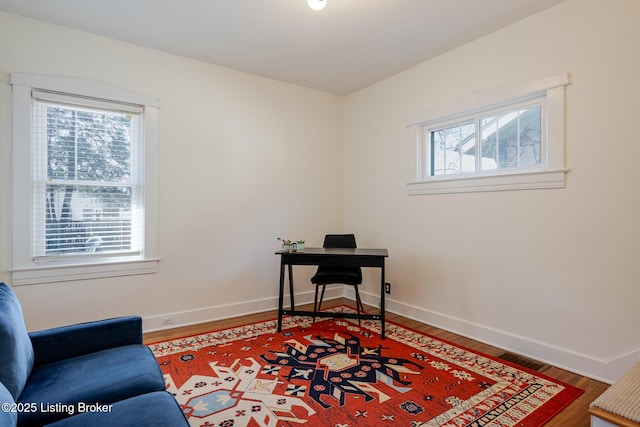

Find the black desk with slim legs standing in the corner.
xmin=276 ymin=248 xmax=389 ymax=338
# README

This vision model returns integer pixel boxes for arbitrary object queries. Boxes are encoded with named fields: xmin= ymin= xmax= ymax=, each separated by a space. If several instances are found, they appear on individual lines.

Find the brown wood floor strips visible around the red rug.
xmin=144 ymin=298 xmax=609 ymax=427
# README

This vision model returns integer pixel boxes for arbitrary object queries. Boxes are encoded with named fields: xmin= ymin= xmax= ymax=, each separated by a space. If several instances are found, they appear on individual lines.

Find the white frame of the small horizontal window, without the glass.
xmin=406 ymin=73 xmax=570 ymax=195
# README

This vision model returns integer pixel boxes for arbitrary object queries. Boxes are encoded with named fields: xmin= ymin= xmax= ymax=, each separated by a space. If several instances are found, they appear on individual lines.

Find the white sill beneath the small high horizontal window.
xmin=407 ymin=169 xmax=567 ymax=196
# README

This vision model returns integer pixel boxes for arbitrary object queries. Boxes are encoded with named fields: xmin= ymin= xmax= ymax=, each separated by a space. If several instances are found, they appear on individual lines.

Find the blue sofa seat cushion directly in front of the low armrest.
xmin=18 ymin=344 xmax=165 ymax=426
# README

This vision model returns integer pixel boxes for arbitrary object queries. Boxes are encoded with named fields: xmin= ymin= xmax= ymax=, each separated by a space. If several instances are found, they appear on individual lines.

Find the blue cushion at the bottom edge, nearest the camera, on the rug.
xmin=42 ymin=391 xmax=189 ymax=427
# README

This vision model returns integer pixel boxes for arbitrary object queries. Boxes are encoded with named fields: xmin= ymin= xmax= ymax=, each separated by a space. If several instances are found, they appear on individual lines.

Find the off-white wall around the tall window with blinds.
xmin=0 ymin=12 xmax=343 ymax=330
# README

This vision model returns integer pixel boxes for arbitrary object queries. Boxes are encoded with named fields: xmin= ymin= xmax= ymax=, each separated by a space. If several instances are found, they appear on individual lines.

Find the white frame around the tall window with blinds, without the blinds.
xmin=10 ymin=73 xmax=159 ymax=285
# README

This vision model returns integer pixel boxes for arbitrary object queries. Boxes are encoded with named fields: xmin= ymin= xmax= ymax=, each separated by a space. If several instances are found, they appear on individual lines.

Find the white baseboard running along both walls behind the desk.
xmin=143 ymin=287 xmax=640 ymax=384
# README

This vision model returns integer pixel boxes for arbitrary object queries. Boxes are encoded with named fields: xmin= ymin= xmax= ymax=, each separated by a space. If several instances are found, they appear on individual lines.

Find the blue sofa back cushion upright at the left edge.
xmin=0 ymin=283 xmax=33 ymax=399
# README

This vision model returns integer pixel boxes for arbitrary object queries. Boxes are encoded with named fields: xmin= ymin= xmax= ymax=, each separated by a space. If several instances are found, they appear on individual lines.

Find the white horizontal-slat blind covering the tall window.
xmin=31 ymin=90 xmax=144 ymax=261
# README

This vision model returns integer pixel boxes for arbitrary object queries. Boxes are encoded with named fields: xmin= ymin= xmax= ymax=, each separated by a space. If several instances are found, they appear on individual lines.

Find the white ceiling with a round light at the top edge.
xmin=0 ymin=0 xmax=563 ymax=95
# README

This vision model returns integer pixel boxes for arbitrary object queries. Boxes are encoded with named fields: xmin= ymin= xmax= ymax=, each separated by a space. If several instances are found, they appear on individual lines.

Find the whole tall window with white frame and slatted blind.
xmin=11 ymin=74 xmax=157 ymax=284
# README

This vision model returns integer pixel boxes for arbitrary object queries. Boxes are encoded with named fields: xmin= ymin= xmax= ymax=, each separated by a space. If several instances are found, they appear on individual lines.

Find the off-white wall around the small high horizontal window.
xmin=345 ymin=0 xmax=640 ymax=381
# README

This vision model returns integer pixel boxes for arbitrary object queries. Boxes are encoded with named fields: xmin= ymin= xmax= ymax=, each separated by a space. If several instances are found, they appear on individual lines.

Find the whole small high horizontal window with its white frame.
xmin=408 ymin=75 xmax=569 ymax=194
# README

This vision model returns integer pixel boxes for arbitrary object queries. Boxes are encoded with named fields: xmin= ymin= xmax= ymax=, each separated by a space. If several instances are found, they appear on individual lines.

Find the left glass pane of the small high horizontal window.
xmin=430 ymin=122 xmax=476 ymax=175
